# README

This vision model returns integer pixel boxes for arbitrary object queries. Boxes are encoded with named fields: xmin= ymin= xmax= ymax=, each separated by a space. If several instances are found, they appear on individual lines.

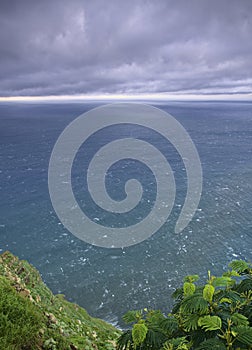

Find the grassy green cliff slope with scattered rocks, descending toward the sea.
xmin=0 ymin=252 xmax=120 ymax=350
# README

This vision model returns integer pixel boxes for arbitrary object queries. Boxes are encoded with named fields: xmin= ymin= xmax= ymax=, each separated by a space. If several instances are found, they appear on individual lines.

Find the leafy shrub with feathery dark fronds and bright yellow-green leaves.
xmin=117 ymin=260 xmax=252 ymax=350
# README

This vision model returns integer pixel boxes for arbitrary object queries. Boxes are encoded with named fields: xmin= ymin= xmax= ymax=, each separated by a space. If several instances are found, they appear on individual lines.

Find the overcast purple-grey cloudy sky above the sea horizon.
xmin=0 ymin=0 xmax=252 ymax=97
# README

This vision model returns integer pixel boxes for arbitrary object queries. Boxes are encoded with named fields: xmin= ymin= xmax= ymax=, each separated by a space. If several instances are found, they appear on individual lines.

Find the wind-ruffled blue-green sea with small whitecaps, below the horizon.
xmin=0 ymin=102 xmax=252 ymax=324
